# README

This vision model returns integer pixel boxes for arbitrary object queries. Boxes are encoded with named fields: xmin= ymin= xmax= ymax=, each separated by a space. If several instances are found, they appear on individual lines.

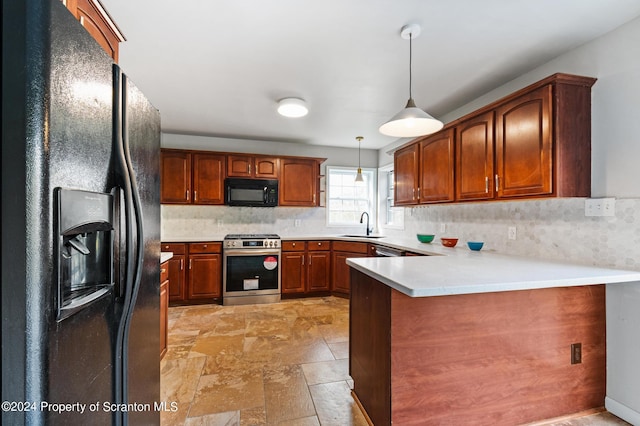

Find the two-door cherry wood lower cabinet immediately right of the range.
xmin=282 ymin=241 xmax=331 ymax=294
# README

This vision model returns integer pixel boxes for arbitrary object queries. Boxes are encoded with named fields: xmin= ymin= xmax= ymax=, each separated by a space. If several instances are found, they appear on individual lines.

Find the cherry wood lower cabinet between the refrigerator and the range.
xmin=162 ymin=242 xmax=222 ymax=303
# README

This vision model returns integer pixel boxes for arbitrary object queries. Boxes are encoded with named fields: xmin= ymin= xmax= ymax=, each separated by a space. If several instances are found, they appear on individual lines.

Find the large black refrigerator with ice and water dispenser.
xmin=1 ymin=0 xmax=162 ymax=425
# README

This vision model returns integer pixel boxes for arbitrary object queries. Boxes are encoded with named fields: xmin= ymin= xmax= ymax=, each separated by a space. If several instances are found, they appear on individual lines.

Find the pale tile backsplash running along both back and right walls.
xmin=161 ymin=198 xmax=640 ymax=270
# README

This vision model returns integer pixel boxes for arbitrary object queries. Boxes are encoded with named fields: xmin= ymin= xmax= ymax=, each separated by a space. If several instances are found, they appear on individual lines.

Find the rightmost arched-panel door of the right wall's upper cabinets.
xmin=495 ymin=85 xmax=553 ymax=198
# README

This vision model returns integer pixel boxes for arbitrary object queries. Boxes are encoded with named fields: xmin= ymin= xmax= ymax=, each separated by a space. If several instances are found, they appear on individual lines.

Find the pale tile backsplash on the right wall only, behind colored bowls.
xmin=384 ymin=198 xmax=640 ymax=270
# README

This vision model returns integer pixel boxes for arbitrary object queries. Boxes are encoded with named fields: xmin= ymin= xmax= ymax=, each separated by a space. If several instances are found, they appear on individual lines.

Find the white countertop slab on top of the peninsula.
xmin=347 ymin=250 xmax=640 ymax=297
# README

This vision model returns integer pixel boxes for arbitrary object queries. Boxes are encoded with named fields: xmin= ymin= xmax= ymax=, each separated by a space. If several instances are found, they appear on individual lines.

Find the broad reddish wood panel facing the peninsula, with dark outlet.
xmin=390 ymin=284 xmax=606 ymax=425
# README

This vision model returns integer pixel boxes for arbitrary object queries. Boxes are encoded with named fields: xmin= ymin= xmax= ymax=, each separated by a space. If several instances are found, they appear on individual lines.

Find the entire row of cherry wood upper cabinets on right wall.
xmin=394 ymin=74 xmax=596 ymax=205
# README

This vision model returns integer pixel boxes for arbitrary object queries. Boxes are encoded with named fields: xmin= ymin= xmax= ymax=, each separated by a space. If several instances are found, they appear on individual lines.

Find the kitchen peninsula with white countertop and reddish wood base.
xmin=347 ymin=251 xmax=640 ymax=425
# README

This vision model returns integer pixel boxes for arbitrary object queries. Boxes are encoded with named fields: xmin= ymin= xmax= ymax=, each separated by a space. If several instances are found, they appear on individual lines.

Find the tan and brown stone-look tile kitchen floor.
xmin=161 ymin=297 xmax=627 ymax=426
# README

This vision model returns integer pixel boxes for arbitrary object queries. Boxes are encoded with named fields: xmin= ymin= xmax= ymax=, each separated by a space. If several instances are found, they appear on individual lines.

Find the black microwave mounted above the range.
xmin=224 ymin=178 xmax=278 ymax=207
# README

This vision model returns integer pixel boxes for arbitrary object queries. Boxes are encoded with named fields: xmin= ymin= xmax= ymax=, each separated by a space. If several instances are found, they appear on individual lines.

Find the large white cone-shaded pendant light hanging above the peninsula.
xmin=379 ymin=24 xmax=443 ymax=138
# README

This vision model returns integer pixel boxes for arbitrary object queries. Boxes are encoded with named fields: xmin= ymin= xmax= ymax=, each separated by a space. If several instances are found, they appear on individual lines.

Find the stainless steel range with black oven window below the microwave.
xmin=222 ymin=234 xmax=281 ymax=305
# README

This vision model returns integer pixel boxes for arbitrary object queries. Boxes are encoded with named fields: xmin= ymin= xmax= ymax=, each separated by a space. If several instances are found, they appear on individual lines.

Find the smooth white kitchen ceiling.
xmin=101 ymin=0 xmax=640 ymax=148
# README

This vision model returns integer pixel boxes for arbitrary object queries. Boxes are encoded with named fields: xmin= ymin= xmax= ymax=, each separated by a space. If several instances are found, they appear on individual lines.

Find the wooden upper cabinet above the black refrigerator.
xmin=62 ymin=0 xmax=125 ymax=62
